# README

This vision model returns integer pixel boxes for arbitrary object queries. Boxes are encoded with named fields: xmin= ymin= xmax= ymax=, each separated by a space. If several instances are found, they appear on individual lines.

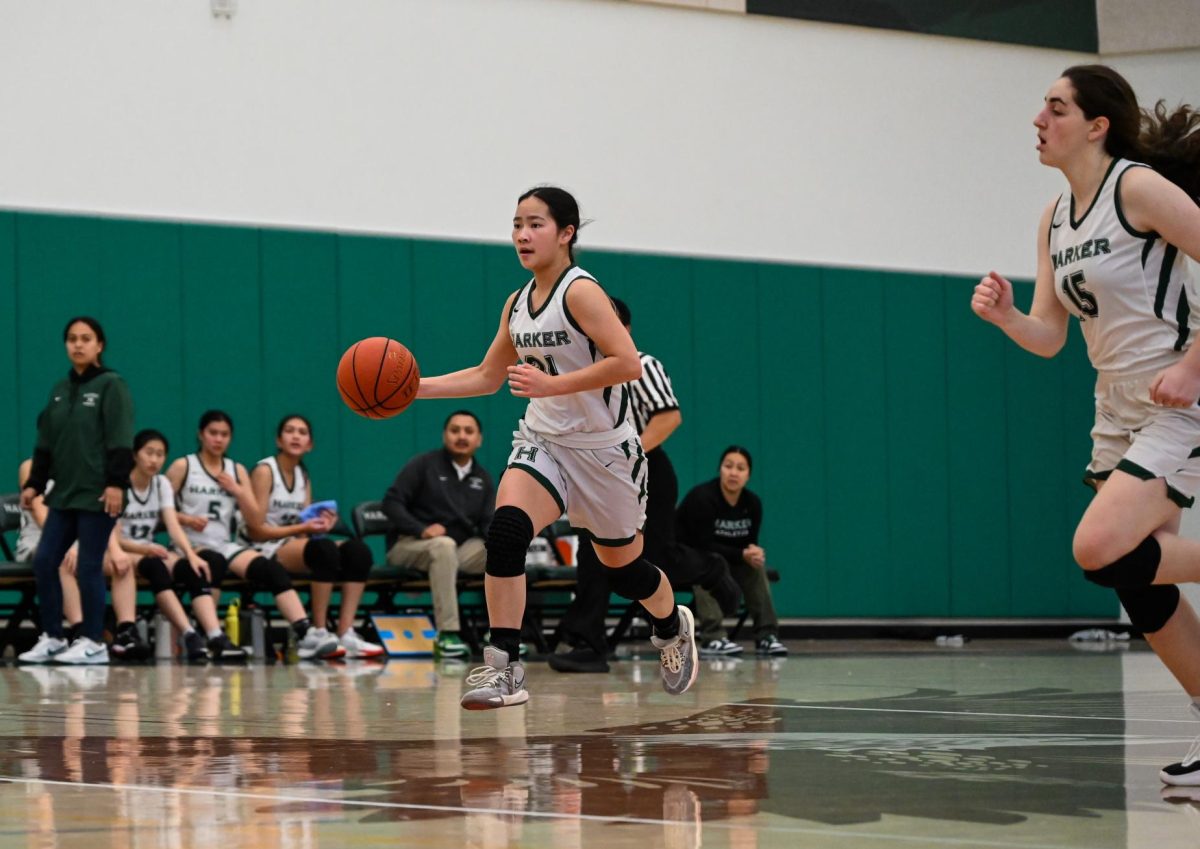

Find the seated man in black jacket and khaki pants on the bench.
xmin=383 ymin=410 xmax=496 ymax=657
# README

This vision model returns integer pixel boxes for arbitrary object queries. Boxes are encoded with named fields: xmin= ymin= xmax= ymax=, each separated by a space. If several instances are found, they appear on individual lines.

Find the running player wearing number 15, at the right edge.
xmin=971 ymin=65 xmax=1200 ymax=784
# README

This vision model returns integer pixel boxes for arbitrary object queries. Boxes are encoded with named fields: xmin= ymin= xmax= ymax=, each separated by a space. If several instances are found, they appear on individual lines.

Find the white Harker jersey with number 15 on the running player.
xmin=1050 ymin=159 xmax=1200 ymax=374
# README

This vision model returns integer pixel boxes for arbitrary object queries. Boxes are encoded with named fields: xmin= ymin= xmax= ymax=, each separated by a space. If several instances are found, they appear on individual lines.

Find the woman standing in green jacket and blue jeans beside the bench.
xmin=18 ymin=315 xmax=133 ymax=663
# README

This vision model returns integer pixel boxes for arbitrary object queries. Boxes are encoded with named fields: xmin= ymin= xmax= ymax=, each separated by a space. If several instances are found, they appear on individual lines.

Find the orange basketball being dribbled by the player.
xmin=337 ymin=336 xmax=421 ymax=419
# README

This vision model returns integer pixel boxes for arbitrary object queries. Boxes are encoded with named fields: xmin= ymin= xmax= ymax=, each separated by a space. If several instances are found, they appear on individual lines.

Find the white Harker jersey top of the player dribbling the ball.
xmin=509 ymin=265 xmax=637 ymax=448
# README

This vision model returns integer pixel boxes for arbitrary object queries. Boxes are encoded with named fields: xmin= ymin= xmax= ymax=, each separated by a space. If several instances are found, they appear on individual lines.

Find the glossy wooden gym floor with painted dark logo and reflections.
xmin=0 ymin=640 xmax=1200 ymax=849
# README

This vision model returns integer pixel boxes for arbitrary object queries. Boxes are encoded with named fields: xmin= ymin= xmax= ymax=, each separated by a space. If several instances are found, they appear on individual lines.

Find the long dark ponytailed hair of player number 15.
xmin=1062 ymin=65 xmax=1200 ymax=204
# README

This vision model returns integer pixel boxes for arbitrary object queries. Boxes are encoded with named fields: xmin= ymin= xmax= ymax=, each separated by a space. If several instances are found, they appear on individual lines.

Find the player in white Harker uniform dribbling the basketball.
xmin=418 ymin=186 xmax=697 ymax=710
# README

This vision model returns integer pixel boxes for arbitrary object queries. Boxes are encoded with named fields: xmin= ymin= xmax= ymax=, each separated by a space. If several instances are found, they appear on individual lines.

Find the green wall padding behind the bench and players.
xmin=0 ymin=212 xmax=1117 ymax=618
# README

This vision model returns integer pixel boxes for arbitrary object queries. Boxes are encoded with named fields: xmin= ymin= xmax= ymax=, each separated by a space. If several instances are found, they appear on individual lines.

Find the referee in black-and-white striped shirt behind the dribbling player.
xmin=550 ymin=297 xmax=742 ymax=673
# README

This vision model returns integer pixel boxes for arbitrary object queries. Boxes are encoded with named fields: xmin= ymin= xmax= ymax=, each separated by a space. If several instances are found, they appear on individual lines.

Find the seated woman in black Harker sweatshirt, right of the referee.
xmin=676 ymin=445 xmax=787 ymax=657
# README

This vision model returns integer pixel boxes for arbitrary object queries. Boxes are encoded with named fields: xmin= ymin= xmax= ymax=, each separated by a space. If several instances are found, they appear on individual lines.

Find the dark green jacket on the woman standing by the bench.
xmin=26 ymin=366 xmax=133 ymax=512
